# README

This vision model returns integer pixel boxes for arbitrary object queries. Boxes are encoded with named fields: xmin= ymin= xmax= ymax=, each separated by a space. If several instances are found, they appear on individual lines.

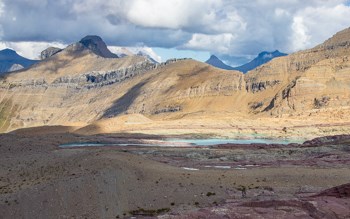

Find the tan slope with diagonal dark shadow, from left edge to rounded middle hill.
xmin=0 ymin=56 xmax=245 ymax=130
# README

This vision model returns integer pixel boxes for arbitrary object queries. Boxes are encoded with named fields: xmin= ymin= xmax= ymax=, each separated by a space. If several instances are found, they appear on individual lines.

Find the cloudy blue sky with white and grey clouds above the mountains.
xmin=0 ymin=0 xmax=350 ymax=66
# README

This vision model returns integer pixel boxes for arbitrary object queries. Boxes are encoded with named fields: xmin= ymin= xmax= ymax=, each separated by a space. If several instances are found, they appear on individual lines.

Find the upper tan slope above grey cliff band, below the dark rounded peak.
xmin=1 ymin=37 xmax=146 ymax=83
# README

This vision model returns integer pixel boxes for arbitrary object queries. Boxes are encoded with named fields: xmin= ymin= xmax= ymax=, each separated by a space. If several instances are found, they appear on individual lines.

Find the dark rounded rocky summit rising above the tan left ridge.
xmin=79 ymin=35 xmax=118 ymax=58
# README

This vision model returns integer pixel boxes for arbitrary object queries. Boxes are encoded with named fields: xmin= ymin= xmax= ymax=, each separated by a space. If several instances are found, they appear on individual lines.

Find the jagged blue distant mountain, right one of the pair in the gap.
xmin=233 ymin=50 xmax=288 ymax=73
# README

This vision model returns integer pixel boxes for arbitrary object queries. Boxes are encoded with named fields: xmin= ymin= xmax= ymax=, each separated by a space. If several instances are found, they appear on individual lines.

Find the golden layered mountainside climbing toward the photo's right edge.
xmin=246 ymin=28 xmax=350 ymax=116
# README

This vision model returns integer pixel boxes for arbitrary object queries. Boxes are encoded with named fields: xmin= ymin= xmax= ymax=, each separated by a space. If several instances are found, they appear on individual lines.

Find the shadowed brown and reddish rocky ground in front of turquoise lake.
xmin=0 ymin=127 xmax=350 ymax=218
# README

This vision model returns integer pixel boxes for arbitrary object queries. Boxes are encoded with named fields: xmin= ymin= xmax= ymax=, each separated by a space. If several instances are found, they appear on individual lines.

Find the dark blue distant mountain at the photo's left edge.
xmin=0 ymin=49 xmax=37 ymax=74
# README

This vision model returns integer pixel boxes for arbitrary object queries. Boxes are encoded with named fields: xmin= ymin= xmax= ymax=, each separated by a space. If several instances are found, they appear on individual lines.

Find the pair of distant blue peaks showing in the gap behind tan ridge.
xmin=205 ymin=50 xmax=287 ymax=73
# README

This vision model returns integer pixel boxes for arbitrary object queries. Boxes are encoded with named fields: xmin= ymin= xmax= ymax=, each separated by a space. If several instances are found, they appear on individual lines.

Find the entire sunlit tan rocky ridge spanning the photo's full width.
xmin=0 ymin=29 xmax=350 ymax=131
